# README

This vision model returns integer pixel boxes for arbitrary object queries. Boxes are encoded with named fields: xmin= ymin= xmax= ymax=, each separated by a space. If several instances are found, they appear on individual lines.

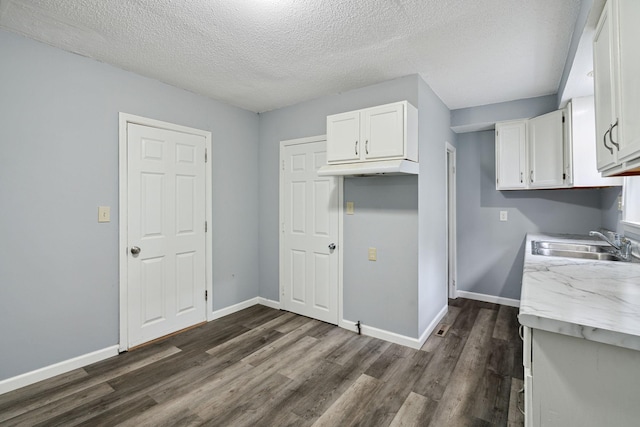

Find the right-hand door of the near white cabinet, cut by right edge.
xmin=609 ymin=0 xmax=640 ymax=162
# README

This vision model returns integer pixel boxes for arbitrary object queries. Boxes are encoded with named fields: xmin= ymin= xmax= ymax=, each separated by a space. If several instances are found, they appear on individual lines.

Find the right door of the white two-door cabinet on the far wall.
xmin=527 ymin=110 xmax=564 ymax=188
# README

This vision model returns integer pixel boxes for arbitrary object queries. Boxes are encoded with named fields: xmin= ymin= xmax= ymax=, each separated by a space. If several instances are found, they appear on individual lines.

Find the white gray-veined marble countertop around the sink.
xmin=518 ymin=233 xmax=640 ymax=350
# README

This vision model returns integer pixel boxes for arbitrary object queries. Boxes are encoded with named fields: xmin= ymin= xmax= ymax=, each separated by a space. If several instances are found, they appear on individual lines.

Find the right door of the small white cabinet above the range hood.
xmin=362 ymin=104 xmax=406 ymax=160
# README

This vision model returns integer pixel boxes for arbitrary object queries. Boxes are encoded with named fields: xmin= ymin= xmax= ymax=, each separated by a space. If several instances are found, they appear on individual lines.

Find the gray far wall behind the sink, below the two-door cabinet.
xmin=457 ymin=131 xmax=608 ymax=299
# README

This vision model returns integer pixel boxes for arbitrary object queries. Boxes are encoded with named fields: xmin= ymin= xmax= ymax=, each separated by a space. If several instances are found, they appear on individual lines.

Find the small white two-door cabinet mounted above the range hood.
xmin=327 ymin=101 xmax=418 ymax=164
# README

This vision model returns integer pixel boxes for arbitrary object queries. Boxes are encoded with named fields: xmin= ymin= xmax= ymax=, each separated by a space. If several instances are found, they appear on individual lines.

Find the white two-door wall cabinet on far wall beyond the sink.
xmin=496 ymin=110 xmax=565 ymax=190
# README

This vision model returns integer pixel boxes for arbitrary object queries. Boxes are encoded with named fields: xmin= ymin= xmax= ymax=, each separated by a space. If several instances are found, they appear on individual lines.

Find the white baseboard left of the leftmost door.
xmin=0 ymin=345 xmax=118 ymax=394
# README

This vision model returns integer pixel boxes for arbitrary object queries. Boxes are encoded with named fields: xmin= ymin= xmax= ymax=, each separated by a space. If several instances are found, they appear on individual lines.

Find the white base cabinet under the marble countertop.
xmin=523 ymin=328 xmax=640 ymax=427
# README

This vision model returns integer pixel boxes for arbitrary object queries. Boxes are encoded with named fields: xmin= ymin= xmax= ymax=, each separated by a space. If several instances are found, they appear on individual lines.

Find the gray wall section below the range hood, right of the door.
xmin=343 ymin=176 xmax=418 ymax=336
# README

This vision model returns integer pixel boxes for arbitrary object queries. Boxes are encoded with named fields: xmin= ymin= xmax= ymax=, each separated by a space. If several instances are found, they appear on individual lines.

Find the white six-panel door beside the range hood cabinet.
xmin=280 ymin=141 xmax=340 ymax=324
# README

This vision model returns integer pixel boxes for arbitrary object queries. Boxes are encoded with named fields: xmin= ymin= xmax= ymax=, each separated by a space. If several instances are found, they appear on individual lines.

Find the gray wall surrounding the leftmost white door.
xmin=0 ymin=30 xmax=259 ymax=380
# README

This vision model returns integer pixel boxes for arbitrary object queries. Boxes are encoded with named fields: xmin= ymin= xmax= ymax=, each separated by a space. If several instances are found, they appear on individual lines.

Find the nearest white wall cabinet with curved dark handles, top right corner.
xmin=593 ymin=0 xmax=640 ymax=176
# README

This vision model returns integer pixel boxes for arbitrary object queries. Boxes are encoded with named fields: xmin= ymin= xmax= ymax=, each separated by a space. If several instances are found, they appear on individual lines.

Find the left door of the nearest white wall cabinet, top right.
xmin=593 ymin=1 xmax=616 ymax=171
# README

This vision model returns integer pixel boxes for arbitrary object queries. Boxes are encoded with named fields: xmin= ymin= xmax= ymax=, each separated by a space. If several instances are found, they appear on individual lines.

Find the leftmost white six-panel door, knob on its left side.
xmin=127 ymin=123 xmax=206 ymax=347
